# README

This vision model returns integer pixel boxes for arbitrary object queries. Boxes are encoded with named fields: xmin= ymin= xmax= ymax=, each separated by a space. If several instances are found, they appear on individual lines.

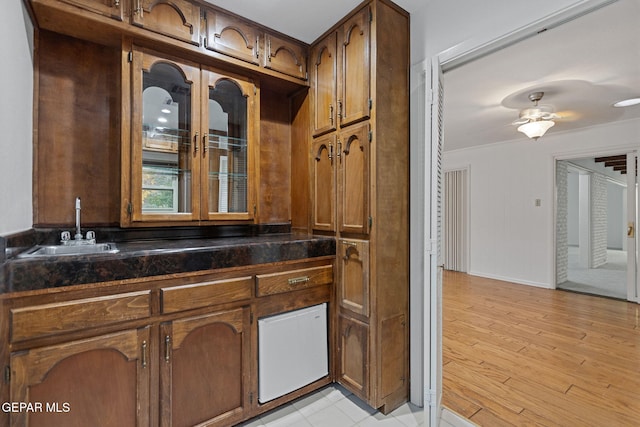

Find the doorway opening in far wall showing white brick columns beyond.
xmin=556 ymin=153 xmax=636 ymax=300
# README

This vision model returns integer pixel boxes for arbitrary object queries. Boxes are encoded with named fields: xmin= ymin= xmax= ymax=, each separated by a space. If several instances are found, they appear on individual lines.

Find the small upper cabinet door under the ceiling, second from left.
xmin=130 ymin=0 xmax=200 ymax=46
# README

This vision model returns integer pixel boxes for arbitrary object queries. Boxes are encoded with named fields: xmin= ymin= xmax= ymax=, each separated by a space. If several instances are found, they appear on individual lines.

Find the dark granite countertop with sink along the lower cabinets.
xmin=0 ymin=233 xmax=336 ymax=293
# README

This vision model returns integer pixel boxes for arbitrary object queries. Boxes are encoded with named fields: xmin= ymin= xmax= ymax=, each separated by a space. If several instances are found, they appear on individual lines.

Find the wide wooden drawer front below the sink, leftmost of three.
xmin=11 ymin=291 xmax=151 ymax=342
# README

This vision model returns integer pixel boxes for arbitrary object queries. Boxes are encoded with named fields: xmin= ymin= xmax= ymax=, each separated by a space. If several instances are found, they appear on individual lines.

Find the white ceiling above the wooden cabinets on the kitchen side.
xmin=206 ymin=0 xmax=424 ymax=43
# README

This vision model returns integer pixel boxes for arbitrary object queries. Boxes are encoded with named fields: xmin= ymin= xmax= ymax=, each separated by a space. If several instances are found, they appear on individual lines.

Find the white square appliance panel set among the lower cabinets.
xmin=258 ymin=303 xmax=329 ymax=403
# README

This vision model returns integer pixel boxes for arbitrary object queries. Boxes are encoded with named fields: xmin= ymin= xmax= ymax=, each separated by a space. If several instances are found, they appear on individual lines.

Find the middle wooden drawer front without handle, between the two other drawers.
xmin=161 ymin=276 xmax=253 ymax=313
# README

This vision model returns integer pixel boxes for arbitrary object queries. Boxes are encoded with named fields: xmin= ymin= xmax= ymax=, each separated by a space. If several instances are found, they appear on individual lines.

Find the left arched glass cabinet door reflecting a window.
xmin=133 ymin=53 xmax=200 ymax=220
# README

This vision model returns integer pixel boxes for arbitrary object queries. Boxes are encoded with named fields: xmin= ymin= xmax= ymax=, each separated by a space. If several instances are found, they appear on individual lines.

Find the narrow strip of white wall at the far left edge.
xmin=0 ymin=0 xmax=33 ymax=235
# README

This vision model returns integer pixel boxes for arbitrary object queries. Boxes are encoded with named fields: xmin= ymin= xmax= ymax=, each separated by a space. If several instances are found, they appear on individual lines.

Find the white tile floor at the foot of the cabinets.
xmin=241 ymin=385 xmax=423 ymax=427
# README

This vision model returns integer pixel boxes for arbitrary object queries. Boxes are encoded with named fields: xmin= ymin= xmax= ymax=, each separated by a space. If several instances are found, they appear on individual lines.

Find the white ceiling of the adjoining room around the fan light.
xmin=444 ymin=0 xmax=640 ymax=151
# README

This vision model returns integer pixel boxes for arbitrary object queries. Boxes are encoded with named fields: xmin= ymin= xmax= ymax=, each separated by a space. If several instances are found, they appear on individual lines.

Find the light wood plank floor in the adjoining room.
xmin=442 ymin=271 xmax=640 ymax=427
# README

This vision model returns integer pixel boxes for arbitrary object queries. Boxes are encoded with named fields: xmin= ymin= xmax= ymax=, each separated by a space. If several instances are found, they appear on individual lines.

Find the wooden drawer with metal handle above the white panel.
xmin=256 ymin=265 xmax=333 ymax=296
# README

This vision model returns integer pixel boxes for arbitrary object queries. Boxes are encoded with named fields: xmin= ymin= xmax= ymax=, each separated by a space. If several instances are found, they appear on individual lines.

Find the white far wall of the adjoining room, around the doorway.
xmin=444 ymin=120 xmax=640 ymax=288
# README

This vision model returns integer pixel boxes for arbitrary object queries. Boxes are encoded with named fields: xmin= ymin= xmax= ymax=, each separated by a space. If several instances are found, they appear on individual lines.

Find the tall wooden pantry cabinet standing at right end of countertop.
xmin=309 ymin=0 xmax=409 ymax=413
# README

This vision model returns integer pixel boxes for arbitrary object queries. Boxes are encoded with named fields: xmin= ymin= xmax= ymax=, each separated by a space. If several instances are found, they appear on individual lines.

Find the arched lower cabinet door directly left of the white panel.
xmin=160 ymin=307 xmax=250 ymax=427
